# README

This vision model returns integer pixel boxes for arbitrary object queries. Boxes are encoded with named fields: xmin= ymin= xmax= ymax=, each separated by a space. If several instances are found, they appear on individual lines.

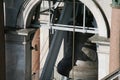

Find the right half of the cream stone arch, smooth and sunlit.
xmin=80 ymin=0 xmax=109 ymax=37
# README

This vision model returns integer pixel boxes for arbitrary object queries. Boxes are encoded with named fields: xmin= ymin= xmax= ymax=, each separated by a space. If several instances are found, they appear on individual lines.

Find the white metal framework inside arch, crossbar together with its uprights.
xmin=36 ymin=1 xmax=99 ymax=34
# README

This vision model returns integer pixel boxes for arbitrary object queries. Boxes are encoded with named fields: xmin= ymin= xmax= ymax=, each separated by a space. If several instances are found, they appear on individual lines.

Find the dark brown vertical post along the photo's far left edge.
xmin=0 ymin=0 xmax=5 ymax=80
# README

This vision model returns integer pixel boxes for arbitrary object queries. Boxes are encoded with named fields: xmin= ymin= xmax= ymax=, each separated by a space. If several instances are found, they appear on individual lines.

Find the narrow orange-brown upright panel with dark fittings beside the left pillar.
xmin=32 ymin=29 xmax=40 ymax=80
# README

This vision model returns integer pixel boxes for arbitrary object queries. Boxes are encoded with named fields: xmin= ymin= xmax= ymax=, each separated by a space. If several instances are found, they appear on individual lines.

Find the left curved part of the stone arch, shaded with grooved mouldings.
xmin=16 ymin=0 xmax=41 ymax=28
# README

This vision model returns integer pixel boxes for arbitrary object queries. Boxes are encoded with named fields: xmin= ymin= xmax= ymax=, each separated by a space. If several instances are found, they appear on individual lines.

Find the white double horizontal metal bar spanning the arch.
xmin=32 ymin=23 xmax=98 ymax=34
